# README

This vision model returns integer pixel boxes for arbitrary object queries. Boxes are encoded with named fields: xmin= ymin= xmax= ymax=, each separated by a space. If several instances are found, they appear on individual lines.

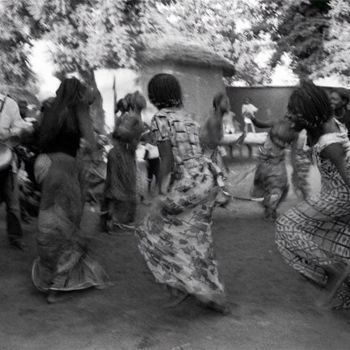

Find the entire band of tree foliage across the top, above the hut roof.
xmin=0 ymin=0 xmax=350 ymax=84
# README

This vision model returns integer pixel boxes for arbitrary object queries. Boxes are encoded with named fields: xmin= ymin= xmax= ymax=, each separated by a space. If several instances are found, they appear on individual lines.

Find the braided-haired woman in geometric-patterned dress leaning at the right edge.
xmin=276 ymin=82 xmax=350 ymax=307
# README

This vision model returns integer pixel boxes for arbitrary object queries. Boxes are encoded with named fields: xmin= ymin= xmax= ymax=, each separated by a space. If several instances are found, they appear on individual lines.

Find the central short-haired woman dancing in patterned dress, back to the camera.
xmin=137 ymin=74 xmax=228 ymax=312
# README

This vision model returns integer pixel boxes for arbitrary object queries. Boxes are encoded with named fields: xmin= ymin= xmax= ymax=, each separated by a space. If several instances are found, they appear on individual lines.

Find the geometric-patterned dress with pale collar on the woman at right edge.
xmin=276 ymin=121 xmax=350 ymax=285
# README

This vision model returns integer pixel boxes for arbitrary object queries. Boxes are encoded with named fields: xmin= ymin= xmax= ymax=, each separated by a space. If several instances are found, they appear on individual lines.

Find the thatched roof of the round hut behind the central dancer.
xmin=139 ymin=37 xmax=235 ymax=76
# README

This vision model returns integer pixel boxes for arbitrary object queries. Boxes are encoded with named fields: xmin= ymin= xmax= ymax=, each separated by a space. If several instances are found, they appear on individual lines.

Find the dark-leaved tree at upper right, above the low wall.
xmin=255 ymin=0 xmax=331 ymax=78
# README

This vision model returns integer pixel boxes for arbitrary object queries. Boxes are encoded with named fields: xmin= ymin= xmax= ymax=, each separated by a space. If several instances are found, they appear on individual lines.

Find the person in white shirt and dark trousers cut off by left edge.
xmin=0 ymin=94 xmax=32 ymax=249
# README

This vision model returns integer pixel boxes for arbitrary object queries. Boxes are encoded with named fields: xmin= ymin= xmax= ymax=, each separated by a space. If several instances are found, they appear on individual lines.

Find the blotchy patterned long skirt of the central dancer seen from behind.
xmin=136 ymin=161 xmax=225 ymax=303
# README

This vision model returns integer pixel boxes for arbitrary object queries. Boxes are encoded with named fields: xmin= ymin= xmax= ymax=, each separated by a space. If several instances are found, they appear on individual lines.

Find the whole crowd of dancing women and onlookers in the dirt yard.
xmin=0 ymin=73 xmax=350 ymax=313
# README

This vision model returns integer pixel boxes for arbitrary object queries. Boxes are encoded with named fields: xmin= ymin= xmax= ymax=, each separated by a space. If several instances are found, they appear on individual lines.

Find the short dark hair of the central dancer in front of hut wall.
xmin=148 ymin=73 xmax=182 ymax=109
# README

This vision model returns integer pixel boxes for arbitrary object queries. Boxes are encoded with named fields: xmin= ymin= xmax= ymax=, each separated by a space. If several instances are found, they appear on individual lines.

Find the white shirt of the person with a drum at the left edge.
xmin=0 ymin=94 xmax=32 ymax=141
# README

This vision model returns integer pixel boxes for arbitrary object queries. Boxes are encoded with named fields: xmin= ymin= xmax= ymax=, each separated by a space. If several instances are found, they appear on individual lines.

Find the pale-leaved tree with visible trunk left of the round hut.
xmin=22 ymin=0 xmax=168 ymax=131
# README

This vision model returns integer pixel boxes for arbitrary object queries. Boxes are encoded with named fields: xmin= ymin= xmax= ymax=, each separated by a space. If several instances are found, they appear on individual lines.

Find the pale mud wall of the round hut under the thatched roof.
xmin=140 ymin=62 xmax=225 ymax=124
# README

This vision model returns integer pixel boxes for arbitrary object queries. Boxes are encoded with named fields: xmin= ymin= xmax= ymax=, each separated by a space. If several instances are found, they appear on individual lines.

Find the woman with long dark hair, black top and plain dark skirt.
xmin=32 ymin=78 xmax=108 ymax=303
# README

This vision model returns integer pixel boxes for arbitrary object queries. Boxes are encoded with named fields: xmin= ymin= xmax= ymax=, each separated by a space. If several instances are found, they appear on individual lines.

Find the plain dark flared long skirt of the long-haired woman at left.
xmin=32 ymin=153 xmax=108 ymax=291
